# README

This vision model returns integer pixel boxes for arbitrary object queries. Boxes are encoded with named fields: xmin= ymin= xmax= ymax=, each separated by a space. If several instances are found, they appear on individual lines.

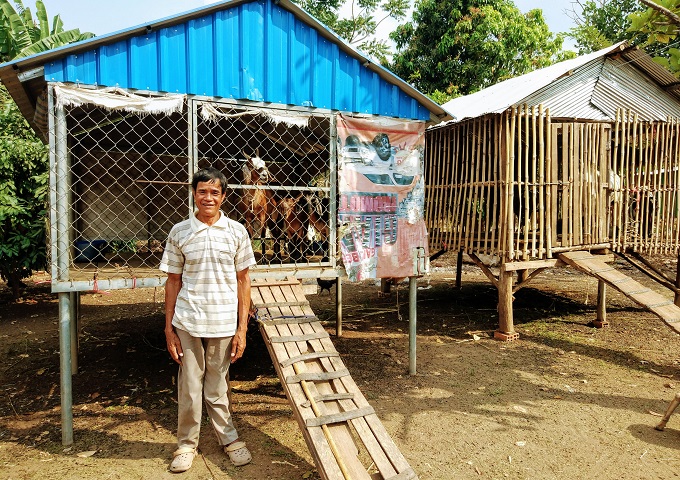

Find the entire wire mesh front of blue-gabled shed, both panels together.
xmin=50 ymin=87 xmax=334 ymax=290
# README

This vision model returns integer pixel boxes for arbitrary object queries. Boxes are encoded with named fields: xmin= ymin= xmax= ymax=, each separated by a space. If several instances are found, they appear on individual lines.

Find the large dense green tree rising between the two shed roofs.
xmin=390 ymin=0 xmax=563 ymax=101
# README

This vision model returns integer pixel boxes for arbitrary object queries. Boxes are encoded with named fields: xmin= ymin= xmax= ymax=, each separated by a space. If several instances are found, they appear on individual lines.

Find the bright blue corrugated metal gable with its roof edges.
xmin=9 ymin=0 xmax=447 ymax=121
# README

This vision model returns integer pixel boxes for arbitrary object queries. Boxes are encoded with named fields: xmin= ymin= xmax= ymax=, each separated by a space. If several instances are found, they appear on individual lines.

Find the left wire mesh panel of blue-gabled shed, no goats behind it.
xmin=52 ymin=97 xmax=189 ymax=281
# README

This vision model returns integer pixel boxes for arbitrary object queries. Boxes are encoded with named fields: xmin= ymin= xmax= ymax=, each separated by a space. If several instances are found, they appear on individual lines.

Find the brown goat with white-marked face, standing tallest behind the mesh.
xmin=239 ymin=149 xmax=277 ymax=258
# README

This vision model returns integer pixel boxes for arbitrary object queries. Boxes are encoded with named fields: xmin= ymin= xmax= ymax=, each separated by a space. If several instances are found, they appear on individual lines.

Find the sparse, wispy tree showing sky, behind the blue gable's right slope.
xmin=293 ymin=0 xmax=411 ymax=63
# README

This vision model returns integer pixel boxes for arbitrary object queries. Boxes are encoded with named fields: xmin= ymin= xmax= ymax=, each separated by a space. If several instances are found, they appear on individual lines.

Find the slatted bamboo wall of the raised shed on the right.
xmin=425 ymin=106 xmax=680 ymax=261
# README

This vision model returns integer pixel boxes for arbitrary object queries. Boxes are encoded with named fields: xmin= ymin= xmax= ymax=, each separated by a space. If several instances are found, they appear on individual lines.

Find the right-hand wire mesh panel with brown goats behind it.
xmin=196 ymin=102 xmax=331 ymax=267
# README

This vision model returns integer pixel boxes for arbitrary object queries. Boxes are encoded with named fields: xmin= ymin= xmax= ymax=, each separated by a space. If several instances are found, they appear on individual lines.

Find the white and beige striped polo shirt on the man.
xmin=159 ymin=212 xmax=255 ymax=337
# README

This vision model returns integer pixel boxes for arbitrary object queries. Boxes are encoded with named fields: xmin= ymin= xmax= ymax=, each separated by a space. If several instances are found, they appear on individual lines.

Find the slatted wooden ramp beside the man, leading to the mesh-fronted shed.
xmin=251 ymin=279 xmax=418 ymax=480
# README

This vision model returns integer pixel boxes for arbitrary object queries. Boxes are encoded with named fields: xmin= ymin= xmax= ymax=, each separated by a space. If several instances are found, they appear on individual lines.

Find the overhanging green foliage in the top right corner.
xmin=629 ymin=0 xmax=680 ymax=76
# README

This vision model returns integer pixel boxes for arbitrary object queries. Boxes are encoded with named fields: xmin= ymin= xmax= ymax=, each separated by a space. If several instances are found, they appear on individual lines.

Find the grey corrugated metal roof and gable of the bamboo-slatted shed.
xmin=443 ymin=42 xmax=680 ymax=121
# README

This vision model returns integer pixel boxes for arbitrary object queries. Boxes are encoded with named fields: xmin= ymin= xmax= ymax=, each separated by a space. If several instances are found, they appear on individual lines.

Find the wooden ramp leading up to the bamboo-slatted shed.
xmin=559 ymin=251 xmax=680 ymax=333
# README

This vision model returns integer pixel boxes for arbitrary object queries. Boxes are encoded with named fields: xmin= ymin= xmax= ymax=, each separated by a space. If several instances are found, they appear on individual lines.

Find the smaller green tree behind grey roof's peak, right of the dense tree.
xmin=568 ymin=0 xmax=643 ymax=55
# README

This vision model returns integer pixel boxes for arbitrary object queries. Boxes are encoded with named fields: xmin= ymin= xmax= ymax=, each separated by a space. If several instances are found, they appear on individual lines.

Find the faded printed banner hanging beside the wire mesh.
xmin=338 ymin=115 xmax=429 ymax=281
